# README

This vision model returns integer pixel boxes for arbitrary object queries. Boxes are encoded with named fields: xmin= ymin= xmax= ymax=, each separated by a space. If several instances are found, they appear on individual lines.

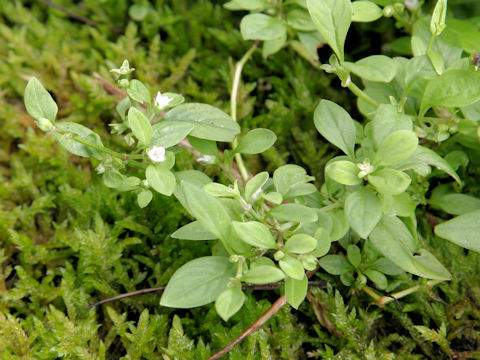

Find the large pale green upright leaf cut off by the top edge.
xmin=307 ymin=0 xmax=353 ymax=62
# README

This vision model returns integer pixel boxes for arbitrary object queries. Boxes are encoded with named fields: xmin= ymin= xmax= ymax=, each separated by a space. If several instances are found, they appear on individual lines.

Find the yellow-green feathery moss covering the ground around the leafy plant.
xmin=0 ymin=0 xmax=480 ymax=359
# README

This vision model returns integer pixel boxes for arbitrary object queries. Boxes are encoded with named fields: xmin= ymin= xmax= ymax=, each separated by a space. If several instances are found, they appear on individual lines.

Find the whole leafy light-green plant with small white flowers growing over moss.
xmin=25 ymin=0 xmax=480 ymax=320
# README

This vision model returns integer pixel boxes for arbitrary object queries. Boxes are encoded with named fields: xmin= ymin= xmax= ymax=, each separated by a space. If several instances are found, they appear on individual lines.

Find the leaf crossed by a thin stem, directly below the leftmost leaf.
xmin=53 ymin=121 xmax=104 ymax=160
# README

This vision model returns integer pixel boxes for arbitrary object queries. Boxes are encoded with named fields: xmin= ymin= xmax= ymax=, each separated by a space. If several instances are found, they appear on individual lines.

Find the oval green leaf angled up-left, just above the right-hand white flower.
xmin=312 ymin=100 xmax=356 ymax=159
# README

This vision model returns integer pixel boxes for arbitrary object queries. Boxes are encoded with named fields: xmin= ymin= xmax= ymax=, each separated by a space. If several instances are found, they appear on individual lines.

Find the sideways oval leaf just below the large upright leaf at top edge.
xmin=343 ymin=54 xmax=397 ymax=83
